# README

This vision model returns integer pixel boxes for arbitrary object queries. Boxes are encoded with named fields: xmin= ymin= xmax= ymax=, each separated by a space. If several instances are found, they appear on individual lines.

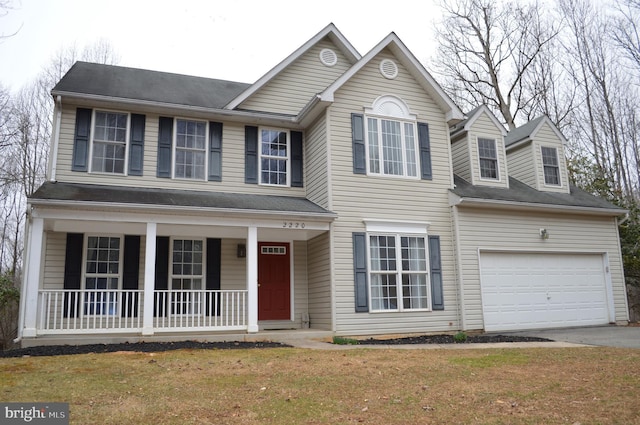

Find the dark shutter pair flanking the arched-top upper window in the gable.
xmin=351 ymin=114 xmax=433 ymax=180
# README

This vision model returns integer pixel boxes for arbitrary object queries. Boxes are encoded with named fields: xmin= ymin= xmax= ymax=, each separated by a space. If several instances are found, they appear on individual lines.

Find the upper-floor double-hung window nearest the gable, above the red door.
xmin=259 ymin=128 xmax=290 ymax=186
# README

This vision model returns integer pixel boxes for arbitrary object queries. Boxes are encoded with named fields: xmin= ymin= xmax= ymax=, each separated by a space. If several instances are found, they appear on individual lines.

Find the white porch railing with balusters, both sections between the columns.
xmin=37 ymin=289 xmax=247 ymax=334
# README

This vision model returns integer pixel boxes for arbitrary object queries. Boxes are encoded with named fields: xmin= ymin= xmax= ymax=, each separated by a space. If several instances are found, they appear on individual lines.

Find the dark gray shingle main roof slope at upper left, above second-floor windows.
xmin=52 ymin=62 xmax=250 ymax=109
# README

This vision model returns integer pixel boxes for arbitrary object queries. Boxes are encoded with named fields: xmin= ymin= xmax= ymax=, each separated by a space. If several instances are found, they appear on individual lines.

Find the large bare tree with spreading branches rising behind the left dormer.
xmin=436 ymin=0 xmax=558 ymax=129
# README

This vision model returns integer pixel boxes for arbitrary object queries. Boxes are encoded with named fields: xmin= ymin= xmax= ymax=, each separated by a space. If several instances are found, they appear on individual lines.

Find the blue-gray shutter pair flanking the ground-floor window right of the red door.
xmin=352 ymin=232 xmax=444 ymax=313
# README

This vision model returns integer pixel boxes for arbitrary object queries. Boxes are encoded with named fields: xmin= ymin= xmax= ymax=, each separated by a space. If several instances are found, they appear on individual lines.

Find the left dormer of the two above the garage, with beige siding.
xmin=451 ymin=105 xmax=509 ymax=188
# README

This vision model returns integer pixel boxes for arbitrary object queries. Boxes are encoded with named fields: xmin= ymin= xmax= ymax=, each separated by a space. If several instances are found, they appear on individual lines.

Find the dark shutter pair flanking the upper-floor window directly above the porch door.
xmin=244 ymin=125 xmax=304 ymax=187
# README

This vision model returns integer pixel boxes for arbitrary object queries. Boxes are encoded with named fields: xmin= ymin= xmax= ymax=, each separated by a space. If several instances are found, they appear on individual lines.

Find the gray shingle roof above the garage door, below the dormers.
xmin=452 ymin=176 xmax=625 ymax=211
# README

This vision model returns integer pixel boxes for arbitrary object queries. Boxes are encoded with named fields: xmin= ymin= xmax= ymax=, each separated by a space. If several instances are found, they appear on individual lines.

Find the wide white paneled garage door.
xmin=480 ymin=252 xmax=609 ymax=331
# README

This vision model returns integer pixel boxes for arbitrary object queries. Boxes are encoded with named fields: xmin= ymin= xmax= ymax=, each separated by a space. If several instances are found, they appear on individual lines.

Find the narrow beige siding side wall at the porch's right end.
xmin=308 ymin=233 xmax=331 ymax=330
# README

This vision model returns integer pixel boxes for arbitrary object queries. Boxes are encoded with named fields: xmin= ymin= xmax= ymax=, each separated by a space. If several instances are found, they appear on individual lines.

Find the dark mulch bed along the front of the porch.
xmin=0 ymin=341 xmax=290 ymax=357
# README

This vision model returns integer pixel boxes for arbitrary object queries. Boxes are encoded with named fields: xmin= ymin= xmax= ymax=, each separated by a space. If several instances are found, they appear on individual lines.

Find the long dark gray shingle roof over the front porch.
xmin=30 ymin=182 xmax=335 ymax=218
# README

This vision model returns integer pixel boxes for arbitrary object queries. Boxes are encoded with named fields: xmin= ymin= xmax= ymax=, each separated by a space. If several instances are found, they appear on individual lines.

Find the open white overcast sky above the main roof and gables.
xmin=0 ymin=0 xmax=439 ymax=90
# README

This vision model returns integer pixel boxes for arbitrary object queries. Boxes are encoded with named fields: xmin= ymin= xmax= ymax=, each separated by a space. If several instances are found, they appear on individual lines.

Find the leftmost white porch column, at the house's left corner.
xmin=21 ymin=218 xmax=44 ymax=338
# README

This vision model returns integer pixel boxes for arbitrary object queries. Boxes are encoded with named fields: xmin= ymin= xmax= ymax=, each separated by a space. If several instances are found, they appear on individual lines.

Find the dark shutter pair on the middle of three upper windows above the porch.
xmin=156 ymin=117 xmax=222 ymax=182
